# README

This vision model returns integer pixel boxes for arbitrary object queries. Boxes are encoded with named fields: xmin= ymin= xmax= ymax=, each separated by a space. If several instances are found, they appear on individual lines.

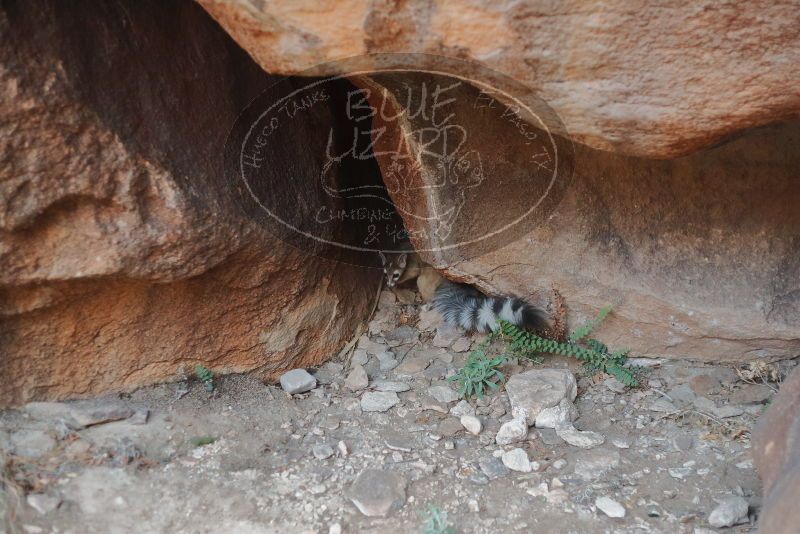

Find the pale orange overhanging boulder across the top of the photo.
xmin=198 ymin=0 xmax=800 ymax=158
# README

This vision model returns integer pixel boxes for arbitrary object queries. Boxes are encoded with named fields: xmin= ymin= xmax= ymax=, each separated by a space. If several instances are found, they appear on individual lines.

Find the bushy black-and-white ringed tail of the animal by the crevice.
xmin=433 ymin=281 xmax=548 ymax=332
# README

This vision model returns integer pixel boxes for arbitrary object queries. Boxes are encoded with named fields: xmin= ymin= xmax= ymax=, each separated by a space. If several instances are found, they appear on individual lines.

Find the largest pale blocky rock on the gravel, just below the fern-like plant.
xmin=506 ymin=369 xmax=578 ymax=426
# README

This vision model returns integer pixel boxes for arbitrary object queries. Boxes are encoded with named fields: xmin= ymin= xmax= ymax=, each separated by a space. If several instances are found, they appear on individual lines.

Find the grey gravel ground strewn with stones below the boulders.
xmin=0 ymin=293 xmax=789 ymax=534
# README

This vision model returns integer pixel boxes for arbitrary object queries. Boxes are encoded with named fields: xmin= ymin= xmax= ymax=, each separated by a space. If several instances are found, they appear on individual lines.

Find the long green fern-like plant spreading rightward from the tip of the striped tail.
xmin=499 ymin=306 xmax=639 ymax=387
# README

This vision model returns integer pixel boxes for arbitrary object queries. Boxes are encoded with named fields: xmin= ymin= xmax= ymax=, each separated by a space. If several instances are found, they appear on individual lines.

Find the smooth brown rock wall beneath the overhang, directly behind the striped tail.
xmin=356 ymin=73 xmax=800 ymax=360
